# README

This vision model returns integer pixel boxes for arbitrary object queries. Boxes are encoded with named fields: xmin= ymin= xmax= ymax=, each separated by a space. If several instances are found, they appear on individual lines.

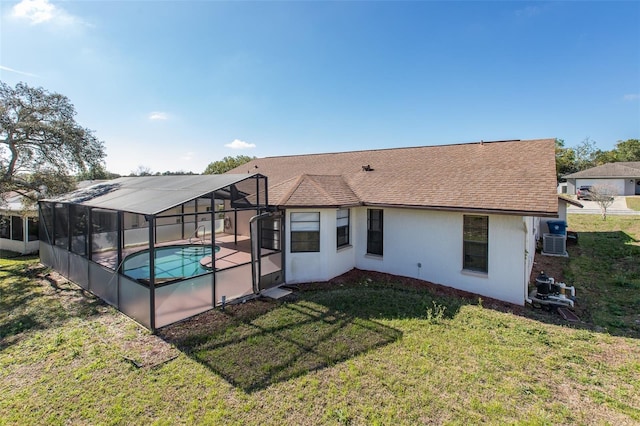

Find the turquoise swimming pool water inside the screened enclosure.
xmin=122 ymin=245 xmax=220 ymax=281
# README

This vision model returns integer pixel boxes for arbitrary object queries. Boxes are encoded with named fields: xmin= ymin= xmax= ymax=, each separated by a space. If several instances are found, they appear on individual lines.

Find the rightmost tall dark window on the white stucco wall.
xmin=462 ymin=215 xmax=489 ymax=272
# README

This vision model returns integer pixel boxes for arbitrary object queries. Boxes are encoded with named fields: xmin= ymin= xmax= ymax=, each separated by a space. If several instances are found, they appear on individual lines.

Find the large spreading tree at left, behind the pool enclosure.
xmin=0 ymin=82 xmax=105 ymax=204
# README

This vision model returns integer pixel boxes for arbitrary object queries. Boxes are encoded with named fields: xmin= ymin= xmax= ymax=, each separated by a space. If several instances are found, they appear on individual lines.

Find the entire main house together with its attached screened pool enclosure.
xmin=40 ymin=139 xmax=561 ymax=329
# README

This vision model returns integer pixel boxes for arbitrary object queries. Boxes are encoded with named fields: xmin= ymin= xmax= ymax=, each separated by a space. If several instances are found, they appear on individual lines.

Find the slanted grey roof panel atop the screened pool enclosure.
xmin=43 ymin=174 xmax=266 ymax=215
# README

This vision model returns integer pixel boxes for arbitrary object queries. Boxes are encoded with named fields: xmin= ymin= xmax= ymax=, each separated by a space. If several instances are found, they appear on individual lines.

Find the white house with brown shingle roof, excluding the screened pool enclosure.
xmin=230 ymin=139 xmax=558 ymax=305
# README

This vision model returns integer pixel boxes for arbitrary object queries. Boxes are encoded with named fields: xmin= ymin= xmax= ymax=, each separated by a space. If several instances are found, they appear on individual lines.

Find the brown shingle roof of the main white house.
xmin=230 ymin=139 xmax=558 ymax=216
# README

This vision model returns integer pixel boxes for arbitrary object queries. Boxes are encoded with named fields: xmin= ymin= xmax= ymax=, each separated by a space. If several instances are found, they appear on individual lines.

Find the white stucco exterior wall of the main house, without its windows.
xmin=285 ymin=207 xmax=528 ymax=304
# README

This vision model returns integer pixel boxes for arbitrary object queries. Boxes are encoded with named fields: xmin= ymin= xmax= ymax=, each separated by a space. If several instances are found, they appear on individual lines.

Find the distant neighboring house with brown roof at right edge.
xmin=564 ymin=161 xmax=640 ymax=195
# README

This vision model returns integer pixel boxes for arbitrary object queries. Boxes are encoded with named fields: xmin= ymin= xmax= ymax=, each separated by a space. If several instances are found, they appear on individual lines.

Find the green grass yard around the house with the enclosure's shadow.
xmin=0 ymin=215 xmax=640 ymax=425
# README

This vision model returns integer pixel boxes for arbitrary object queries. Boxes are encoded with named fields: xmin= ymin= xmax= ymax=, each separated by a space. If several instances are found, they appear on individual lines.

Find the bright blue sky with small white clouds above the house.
xmin=0 ymin=0 xmax=640 ymax=174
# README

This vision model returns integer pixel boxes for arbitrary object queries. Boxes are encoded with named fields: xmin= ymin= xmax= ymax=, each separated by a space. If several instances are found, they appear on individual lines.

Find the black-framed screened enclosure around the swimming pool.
xmin=39 ymin=174 xmax=284 ymax=330
